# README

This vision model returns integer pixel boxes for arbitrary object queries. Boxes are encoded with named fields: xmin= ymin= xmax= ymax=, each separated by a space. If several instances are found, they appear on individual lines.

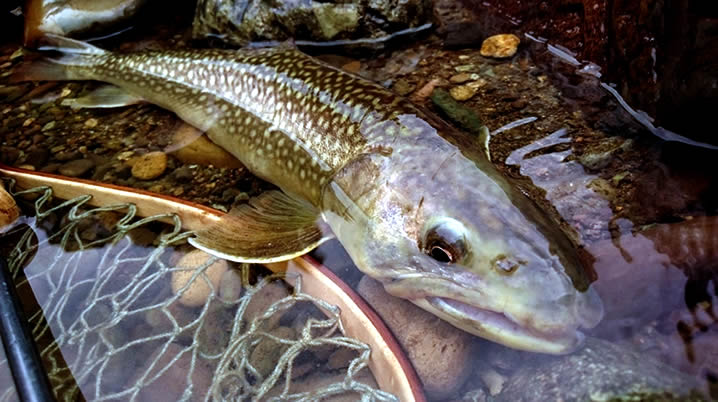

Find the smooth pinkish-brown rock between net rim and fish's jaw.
xmin=358 ymin=276 xmax=476 ymax=399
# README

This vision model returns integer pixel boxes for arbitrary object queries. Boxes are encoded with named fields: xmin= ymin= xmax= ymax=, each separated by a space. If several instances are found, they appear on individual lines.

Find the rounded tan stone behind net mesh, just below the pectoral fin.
xmin=172 ymin=250 xmax=228 ymax=307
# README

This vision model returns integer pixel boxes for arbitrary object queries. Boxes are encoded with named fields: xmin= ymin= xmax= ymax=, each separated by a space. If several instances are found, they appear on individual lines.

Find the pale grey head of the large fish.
xmin=325 ymin=139 xmax=603 ymax=354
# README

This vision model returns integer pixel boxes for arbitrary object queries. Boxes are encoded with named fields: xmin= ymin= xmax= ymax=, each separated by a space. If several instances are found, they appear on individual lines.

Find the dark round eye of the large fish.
xmin=421 ymin=219 xmax=466 ymax=264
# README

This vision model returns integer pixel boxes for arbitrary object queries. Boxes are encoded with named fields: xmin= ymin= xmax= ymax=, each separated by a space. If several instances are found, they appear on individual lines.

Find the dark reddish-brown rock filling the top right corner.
xmin=462 ymin=0 xmax=718 ymax=144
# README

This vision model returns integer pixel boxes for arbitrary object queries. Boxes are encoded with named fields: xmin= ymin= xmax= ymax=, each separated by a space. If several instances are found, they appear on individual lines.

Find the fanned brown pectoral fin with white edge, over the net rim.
xmin=189 ymin=191 xmax=329 ymax=263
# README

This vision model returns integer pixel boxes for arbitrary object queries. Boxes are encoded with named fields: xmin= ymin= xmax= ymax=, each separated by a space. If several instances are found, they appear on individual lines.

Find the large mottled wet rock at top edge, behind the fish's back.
xmin=192 ymin=0 xmax=432 ymax=47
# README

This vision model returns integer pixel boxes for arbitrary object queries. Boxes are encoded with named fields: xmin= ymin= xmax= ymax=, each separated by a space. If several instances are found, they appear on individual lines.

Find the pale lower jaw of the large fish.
xmin=412 ymin=296 xmax=584 ymax=355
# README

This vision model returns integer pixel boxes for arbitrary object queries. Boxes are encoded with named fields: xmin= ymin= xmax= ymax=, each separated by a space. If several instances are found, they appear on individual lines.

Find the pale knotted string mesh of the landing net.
xmin=0 ymin=181 xmax=396 ymax=401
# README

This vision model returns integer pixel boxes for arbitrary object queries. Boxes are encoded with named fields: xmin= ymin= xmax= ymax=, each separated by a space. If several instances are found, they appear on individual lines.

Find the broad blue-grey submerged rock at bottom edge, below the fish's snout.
xmin=497 ymin=338 xmax=698 ymax=401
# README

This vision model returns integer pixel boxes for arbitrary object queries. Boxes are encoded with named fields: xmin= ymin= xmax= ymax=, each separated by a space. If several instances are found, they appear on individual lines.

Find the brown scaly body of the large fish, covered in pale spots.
xmin=75 ymin=49 xmax=416 ymax=205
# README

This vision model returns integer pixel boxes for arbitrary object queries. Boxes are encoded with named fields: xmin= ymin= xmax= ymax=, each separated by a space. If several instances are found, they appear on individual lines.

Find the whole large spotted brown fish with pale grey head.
xmin=11 ymin=35 xmax=603 ymax=354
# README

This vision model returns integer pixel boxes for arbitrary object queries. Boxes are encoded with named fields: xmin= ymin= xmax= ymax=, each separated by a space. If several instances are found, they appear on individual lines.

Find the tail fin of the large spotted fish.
xmin=10 ymin=34 xmax=107 ymax=83
